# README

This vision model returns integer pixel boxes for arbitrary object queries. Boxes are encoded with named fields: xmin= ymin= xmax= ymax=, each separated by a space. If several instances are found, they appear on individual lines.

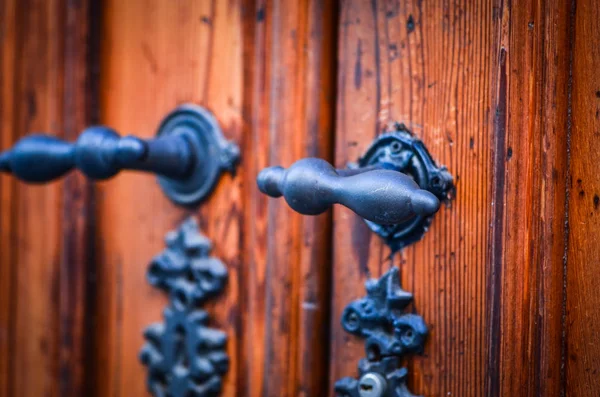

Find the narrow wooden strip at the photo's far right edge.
xmin=566 ymin=0 xmax=600 ymax=396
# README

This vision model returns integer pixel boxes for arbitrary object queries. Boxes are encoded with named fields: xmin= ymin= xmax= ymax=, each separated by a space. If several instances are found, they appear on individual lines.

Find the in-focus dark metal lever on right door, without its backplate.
xmin=258 ymin=158 xmax=440 ymax=225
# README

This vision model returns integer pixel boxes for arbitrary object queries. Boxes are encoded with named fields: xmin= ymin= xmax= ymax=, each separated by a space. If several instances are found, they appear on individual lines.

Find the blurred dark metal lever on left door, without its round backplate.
xmin=0 ymin=126 xmax=197 ymax=183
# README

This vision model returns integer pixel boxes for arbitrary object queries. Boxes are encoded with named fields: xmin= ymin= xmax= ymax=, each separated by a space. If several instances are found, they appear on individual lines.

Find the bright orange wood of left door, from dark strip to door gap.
xmin=96 ymin=1 xmax=335 ymax=397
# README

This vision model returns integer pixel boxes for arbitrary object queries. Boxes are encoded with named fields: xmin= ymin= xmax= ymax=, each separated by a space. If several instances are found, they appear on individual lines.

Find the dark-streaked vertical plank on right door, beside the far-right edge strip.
xmin=488 ymin=1 xmax=571 ymax=396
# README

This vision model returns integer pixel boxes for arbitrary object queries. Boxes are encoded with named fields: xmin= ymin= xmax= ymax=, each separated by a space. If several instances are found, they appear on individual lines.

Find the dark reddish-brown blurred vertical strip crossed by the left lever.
xmin=58 ymin=0 xmax=99 ymax=396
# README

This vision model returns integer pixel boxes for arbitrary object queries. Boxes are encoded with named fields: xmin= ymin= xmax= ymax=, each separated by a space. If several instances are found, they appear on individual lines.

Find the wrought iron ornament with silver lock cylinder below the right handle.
xmin=335 ymin=267 xmax=428 ymax=397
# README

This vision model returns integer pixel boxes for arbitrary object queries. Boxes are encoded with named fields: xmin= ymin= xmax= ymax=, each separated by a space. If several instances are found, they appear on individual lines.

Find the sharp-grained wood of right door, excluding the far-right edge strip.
xmin=330 ymin=0 xmax=570 ymax=396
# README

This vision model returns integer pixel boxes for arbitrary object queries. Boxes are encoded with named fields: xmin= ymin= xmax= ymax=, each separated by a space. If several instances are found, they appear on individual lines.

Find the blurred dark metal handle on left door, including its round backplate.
xmin=0 ymin=105 xmax=239 ymax=205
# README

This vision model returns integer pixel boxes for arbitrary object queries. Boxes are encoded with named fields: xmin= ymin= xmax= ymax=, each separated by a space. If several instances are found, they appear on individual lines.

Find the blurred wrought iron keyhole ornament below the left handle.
xmin=140 ymin=217 xmax=229 ymax=397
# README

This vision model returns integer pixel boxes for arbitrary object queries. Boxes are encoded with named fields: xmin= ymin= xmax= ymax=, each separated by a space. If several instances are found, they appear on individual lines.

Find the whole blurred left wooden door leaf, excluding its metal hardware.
xmin=0 ymin=0 xmax=337 ymax=396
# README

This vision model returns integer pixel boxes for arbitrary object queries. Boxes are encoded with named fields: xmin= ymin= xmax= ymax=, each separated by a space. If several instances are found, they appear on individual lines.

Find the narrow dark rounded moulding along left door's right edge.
xmin=291 ymin=0 xmax=338 ymax=397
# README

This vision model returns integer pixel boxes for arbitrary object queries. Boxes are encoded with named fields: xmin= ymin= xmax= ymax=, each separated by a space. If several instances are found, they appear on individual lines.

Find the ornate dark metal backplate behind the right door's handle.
xmin=349 ymin=123 xmax=455 ymax=252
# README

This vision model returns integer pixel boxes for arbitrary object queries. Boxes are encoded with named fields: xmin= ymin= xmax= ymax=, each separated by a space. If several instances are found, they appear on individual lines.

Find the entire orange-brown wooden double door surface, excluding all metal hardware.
xmin=0 ymin=0 xmax=600 ymax=397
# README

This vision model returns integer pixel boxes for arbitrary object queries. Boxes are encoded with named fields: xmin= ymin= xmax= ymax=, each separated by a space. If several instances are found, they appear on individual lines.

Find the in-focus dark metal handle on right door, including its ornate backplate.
xmin=257 ymin=123 xmax=454 ymax=252
